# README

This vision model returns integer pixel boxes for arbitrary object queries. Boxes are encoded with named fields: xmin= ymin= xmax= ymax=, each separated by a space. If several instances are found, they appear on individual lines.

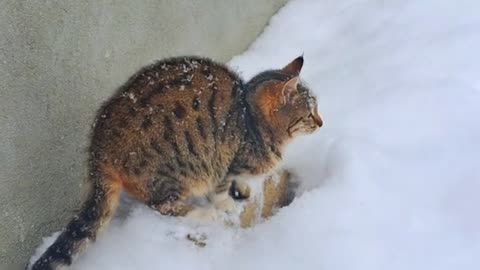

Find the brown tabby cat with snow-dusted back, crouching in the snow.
xmin=32 ymin=56 xmax=323 ymax=270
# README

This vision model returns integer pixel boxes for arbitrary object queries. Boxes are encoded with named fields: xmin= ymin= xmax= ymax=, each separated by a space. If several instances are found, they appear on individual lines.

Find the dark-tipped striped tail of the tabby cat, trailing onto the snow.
xmin=31 ymin=172 xmax=122 ymax=270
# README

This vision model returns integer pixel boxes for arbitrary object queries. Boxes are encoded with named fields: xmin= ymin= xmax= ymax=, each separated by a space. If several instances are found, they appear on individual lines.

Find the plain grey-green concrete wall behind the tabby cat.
xmin=0 ymin=0 xmax=286 ymax=269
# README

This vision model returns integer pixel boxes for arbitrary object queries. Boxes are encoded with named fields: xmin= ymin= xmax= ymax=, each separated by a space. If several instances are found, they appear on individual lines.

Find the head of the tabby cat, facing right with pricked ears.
xmin=249 ymin=56 xmax=323 ymax=138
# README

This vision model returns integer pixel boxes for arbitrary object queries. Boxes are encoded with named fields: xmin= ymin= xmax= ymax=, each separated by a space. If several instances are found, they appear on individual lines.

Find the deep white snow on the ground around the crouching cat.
xmin=31 ymin=0 xmax=480 ymax=270
